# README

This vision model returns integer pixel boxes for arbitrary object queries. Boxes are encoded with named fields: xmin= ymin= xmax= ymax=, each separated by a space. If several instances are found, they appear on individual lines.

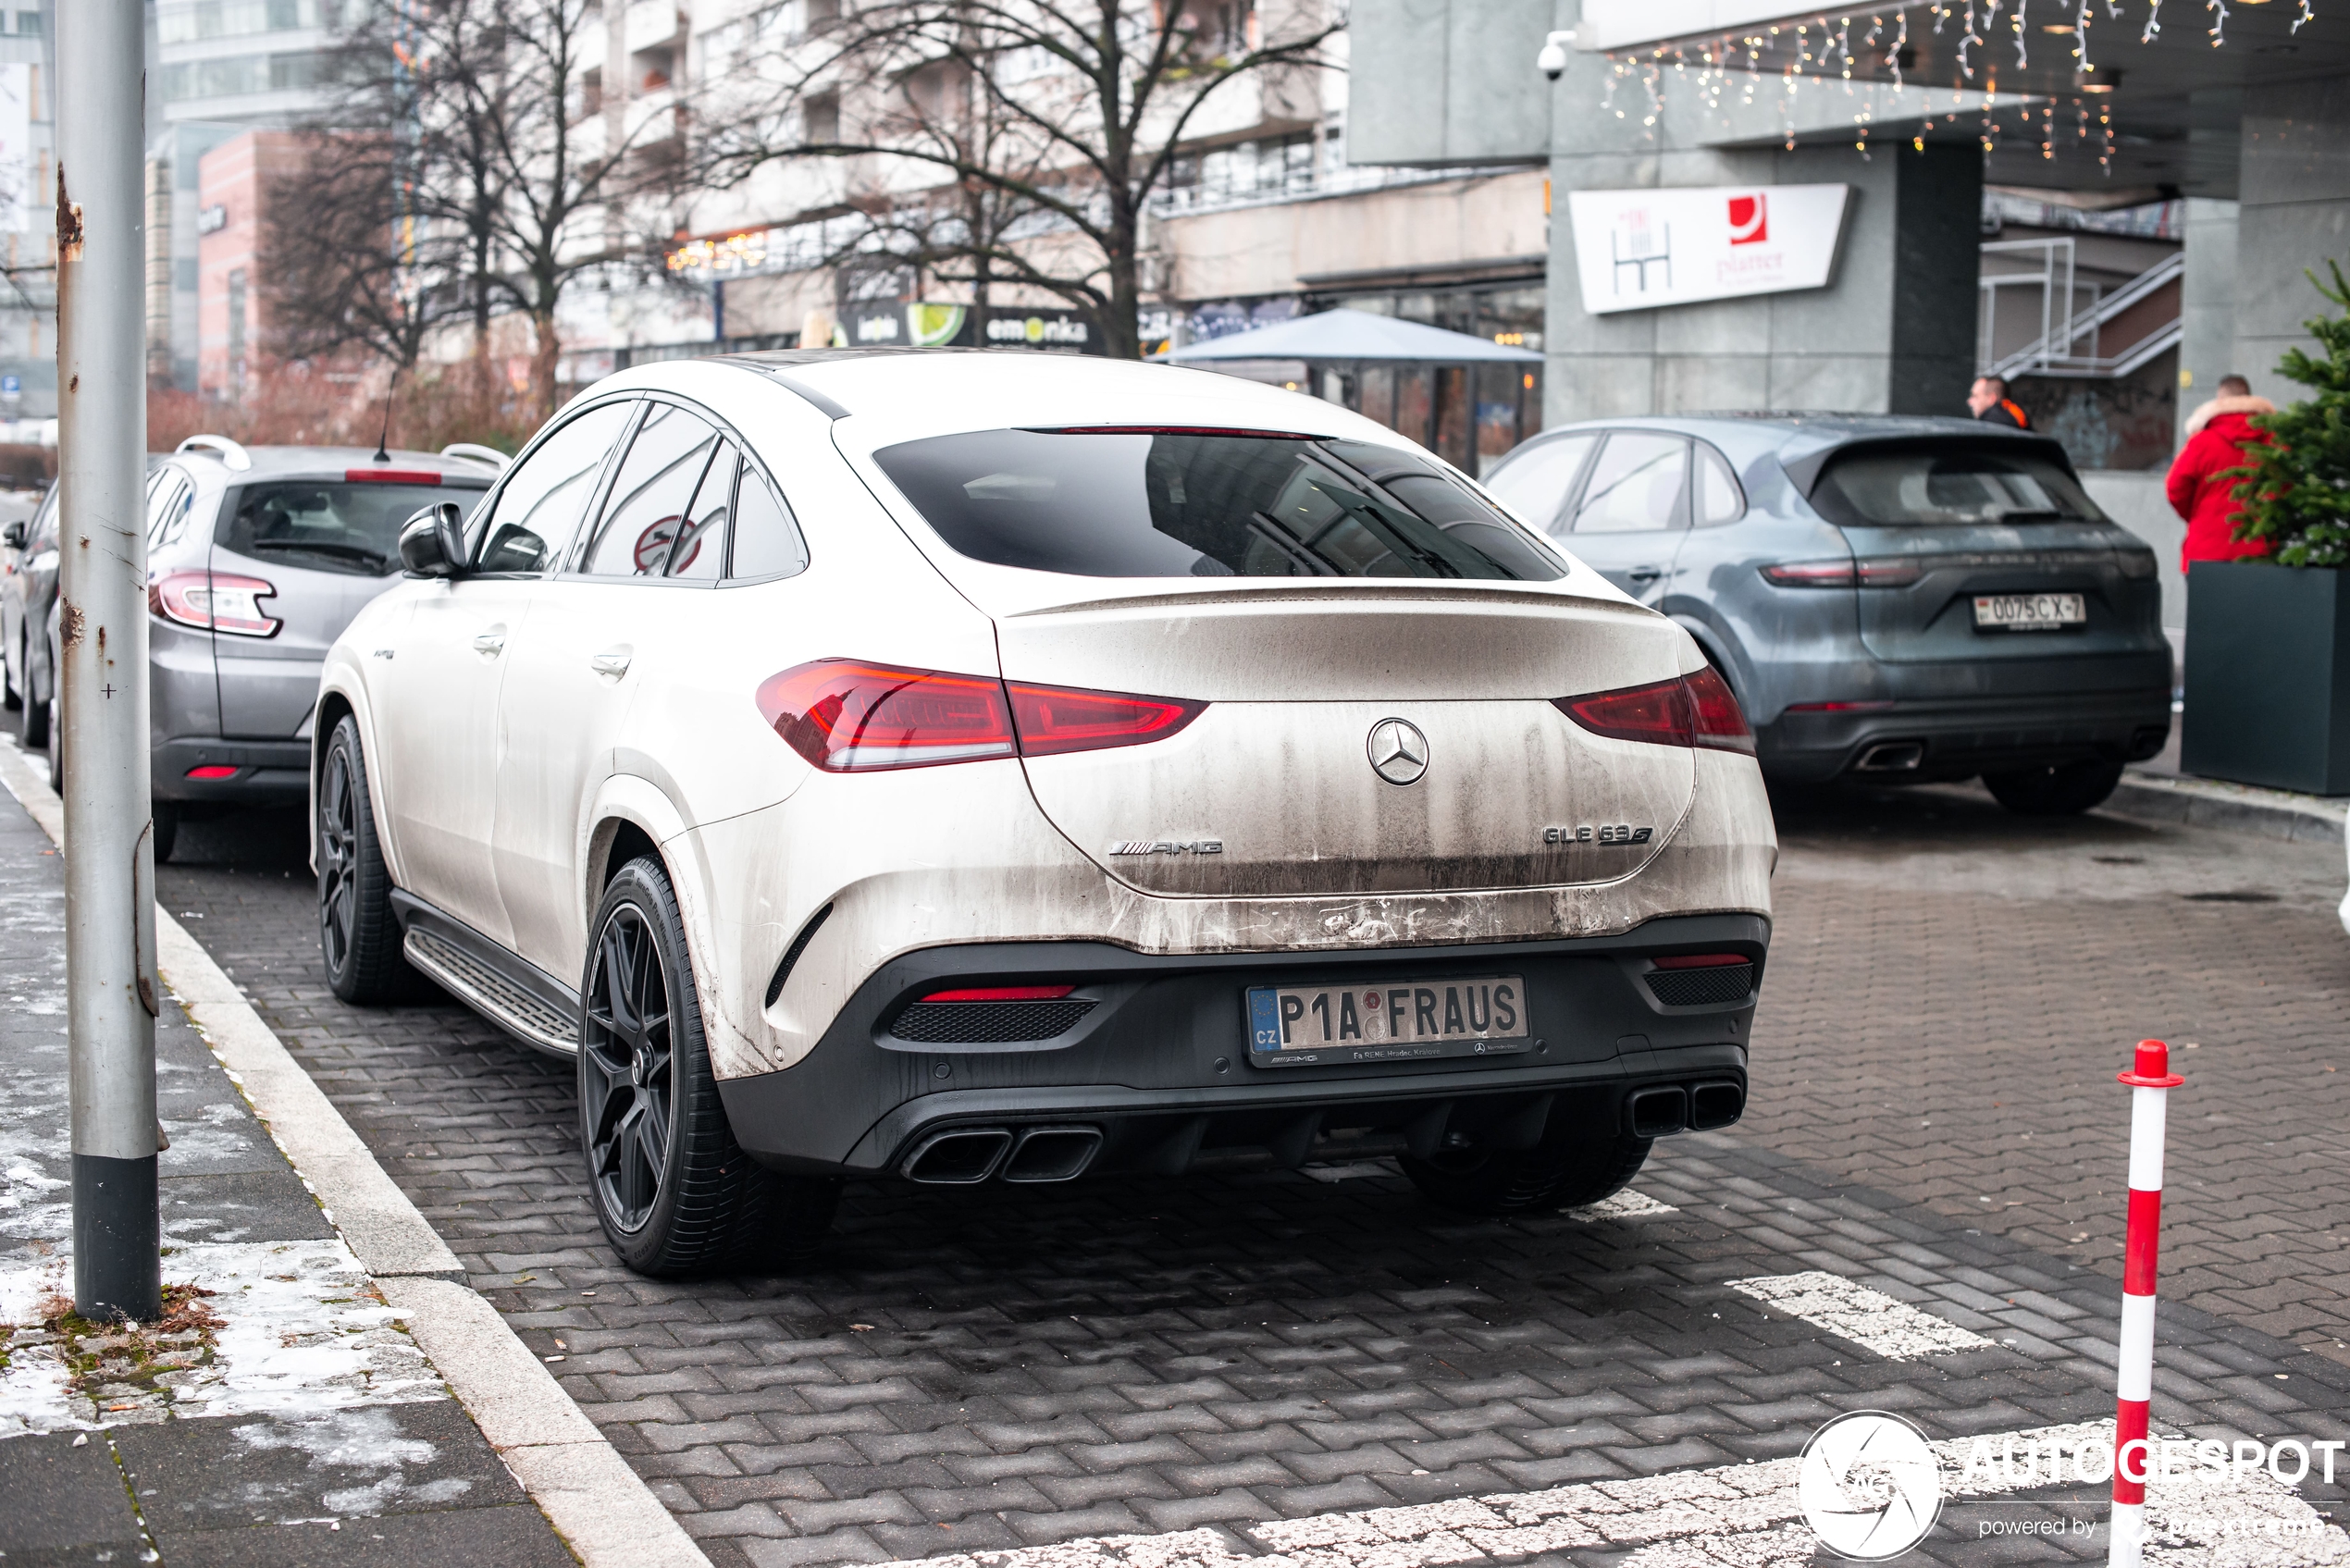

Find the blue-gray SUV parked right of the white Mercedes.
xmin=1485 ymin=414 xmax=2171 ymax=813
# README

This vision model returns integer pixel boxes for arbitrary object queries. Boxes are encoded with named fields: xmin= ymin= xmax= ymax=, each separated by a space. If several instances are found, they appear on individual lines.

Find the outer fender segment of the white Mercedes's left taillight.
xmin=759 ymin=659 xmax=1018 ymax=773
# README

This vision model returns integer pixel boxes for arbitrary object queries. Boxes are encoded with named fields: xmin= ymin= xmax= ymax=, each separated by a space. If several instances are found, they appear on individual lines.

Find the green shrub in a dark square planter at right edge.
xmin=2179 ymin=261 xmax=2350 ymax=795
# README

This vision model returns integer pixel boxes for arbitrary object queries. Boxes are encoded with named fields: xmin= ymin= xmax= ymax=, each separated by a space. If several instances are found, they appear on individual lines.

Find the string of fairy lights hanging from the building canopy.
xmin=1601 ymin=0 xmax=2317 ymax=177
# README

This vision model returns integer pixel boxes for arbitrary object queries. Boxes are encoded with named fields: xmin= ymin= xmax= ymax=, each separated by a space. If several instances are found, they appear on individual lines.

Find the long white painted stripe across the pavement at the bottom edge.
xmin=886 ymin=1420 xmax=2350 ymax=1568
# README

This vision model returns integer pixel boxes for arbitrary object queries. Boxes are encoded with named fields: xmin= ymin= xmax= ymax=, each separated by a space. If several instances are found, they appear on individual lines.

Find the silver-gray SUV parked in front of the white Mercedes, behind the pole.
xmin=9 ymin=435 xmax=505 ymax=860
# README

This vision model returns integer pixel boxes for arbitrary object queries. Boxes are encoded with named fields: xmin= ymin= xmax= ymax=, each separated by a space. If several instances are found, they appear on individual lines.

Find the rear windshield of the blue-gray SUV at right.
xmin=1812 ymin=442 xmax=2106 ymax=526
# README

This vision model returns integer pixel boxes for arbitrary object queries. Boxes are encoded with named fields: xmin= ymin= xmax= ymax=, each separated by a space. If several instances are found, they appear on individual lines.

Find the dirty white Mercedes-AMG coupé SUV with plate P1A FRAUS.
xmin=313 ymin=351 xmax=1776 ymax=1274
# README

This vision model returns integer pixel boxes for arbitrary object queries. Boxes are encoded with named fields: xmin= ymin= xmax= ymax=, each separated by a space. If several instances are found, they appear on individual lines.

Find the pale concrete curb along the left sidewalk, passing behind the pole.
xmin=0 ymin=738 xmax=710 ymax=1568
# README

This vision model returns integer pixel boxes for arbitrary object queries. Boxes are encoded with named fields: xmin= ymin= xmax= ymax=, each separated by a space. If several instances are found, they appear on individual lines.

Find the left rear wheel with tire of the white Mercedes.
xmin=578 ymin=856 xmax=839 ymax=1278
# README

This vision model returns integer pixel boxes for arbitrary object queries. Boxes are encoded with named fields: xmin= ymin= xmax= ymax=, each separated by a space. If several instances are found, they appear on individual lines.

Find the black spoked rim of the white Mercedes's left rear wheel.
xmin=580 ymin=903 xmax=677 ymax=1234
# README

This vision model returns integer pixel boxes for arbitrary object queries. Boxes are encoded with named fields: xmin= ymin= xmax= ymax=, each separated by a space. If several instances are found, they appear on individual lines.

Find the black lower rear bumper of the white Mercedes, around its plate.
xmin=719 ymin=915 xmax=1770 ymax=1176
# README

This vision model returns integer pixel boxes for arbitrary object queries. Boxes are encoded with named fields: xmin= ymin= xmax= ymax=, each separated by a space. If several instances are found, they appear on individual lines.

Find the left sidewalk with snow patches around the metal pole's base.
xmin=0 ymin=796 xmax=574 ymax=1568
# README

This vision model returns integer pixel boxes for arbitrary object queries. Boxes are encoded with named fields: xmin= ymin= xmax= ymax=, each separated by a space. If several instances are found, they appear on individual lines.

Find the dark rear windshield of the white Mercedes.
xmin=874 ymin=430 xmax=1565 ymax=583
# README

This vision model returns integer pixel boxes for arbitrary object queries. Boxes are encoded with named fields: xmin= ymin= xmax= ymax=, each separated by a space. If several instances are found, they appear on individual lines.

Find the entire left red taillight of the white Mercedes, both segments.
xmin=759 ymin=659 xmax=1206 ymax=773
